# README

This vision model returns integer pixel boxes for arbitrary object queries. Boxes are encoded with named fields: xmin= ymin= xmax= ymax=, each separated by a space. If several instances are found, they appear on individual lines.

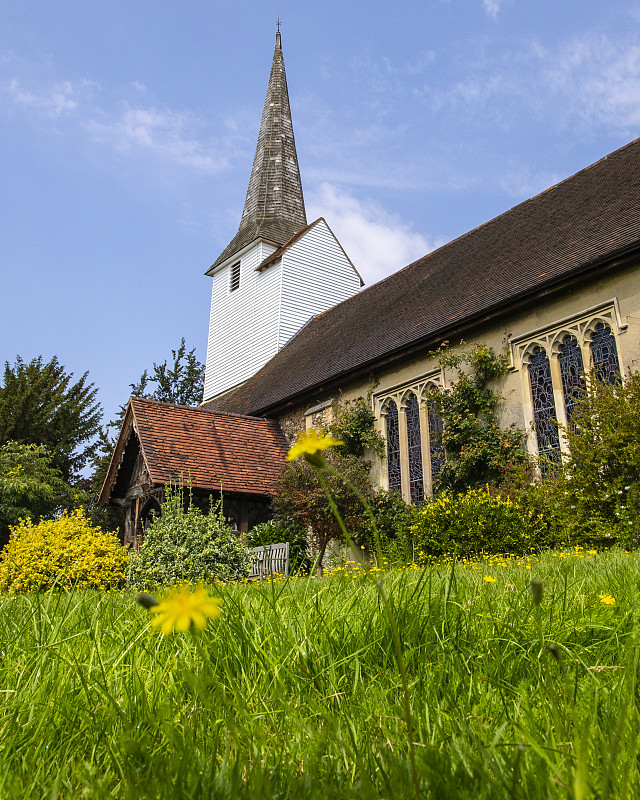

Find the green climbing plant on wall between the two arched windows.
xmin=432 ymin=344 xmax=530 ymax=494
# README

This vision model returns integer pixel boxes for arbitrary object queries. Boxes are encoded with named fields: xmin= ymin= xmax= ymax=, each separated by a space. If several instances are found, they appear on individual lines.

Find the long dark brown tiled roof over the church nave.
xmin=207 ymin=139 xmax=640 ymax=414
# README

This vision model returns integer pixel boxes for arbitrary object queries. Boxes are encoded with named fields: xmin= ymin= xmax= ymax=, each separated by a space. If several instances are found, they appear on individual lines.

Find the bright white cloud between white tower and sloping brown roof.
xmin=307 ymin=183 xmax=443 ymax=285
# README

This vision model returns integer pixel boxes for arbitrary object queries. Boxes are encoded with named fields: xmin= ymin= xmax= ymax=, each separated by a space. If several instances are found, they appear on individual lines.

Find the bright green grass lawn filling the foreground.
xmin=0 ymin=551 xmax=640 ymax=800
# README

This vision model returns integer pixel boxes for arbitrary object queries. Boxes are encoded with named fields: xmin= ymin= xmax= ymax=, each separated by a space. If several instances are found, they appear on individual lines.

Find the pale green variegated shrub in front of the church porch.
xmin=129 ymin=487 xmax=250 ymax=588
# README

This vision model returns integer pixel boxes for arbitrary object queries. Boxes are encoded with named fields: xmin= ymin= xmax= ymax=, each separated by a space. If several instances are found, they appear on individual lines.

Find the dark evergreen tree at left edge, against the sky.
xmin=0 ymin=356 xmax=102 ymax=482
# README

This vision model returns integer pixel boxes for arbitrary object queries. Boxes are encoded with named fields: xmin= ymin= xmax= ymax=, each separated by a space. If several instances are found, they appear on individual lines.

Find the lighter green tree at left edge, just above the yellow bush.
xmin=0 ymin=442 xmax=83 ymax=547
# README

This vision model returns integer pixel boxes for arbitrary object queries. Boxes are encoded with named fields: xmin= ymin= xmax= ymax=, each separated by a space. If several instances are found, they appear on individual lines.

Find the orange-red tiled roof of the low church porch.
xmin=100 ymin=397 xmax=287 ymax=502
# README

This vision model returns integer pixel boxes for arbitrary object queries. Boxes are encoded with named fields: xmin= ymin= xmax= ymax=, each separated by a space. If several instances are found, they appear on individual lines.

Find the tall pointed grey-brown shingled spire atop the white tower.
xmin=213 ymin=31 xmax=307 ymax=267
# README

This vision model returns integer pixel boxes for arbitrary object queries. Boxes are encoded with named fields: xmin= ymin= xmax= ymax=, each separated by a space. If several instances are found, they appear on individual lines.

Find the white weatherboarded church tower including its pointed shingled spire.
xmin=203 ymin=31 xmax=362 ymax=402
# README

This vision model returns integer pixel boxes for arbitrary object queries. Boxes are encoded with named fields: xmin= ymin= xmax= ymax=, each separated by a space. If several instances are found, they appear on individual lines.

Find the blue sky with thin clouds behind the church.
xmin=0 ymin=0 xmax=640 ymax=432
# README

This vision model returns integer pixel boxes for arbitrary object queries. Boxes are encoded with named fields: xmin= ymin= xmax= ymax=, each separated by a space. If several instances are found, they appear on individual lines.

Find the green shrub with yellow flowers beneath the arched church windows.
xmin=411 ymin=489 xmax=538 ymax=560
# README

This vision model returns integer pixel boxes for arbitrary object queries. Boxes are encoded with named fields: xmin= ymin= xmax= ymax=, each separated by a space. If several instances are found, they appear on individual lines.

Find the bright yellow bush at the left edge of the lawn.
xmin=0 ymin=509 xmax=129 ymax=593
